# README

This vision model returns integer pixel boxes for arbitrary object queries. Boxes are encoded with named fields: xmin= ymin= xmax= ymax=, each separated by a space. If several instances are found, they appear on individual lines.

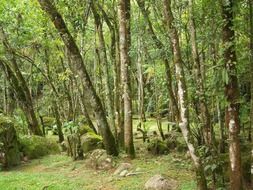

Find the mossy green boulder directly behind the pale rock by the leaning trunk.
xmin=81 ymin=132 xmax=103 ymax=153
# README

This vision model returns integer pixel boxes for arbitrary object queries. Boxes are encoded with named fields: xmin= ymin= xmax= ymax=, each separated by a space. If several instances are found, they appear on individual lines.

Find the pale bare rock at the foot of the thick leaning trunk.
xmin=86 ymin=149 xmax=114 ymax=170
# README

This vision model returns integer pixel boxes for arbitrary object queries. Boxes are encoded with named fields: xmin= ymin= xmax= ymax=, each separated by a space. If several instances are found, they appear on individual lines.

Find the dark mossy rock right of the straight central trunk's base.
xmin=147 ymin=139 xmax=169 ymax=155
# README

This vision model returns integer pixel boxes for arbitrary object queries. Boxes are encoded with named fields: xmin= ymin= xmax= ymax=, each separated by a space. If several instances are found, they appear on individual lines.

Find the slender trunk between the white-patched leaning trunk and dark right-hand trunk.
xmin=189 ymin=0 xmax=214 ymax=145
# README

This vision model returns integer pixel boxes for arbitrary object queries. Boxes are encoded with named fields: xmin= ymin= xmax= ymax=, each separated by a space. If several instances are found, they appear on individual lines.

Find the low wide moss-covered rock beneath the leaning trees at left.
xmin=20 ymin=135 xmax=60 ymax=159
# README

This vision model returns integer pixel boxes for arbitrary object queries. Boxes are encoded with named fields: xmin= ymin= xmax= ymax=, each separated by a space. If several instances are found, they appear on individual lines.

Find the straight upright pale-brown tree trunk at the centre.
xmin=119 ymin=0 xmax=135 ymax=158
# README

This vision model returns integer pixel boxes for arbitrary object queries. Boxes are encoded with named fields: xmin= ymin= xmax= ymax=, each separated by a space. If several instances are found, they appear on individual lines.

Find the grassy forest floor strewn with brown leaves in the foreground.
xmin=0 ymin=119 xmax=195 ymax=190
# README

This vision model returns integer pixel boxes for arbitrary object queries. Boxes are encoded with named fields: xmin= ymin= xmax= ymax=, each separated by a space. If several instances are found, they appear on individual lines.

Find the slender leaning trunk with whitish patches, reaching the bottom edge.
xmin=163 ymin=0 xmax=207 ymax=190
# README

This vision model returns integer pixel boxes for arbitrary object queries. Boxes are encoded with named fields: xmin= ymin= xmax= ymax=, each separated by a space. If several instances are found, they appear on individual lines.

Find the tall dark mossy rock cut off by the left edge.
xmin=0 ymin=115 xmax=20 ymax=168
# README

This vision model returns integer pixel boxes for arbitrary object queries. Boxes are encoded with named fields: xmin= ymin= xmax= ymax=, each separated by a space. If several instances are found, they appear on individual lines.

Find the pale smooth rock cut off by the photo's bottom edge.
xmin=145 ymin=175 xmax=178 ymax=190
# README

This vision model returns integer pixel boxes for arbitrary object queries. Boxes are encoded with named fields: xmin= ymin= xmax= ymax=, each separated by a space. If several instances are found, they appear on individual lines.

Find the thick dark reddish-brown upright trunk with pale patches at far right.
xmin=222 ymin=0 xmax=242 ymax=190
